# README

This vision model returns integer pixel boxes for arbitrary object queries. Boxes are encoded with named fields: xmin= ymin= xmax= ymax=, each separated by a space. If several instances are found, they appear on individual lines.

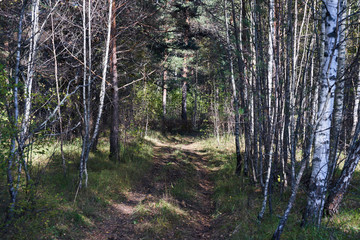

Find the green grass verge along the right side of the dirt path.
xmin=194 ymin=137 xmax=360 ymax=239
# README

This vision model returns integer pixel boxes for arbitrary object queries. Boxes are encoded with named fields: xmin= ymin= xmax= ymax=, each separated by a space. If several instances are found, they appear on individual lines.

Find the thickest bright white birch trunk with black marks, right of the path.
xmin=304 ymin=0 xmax=338 ymax=226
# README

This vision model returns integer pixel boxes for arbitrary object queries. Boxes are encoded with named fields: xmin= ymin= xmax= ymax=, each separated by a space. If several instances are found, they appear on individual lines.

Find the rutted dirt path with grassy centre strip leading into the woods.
xmin=87 ymin=137 xmax=215 ymax=239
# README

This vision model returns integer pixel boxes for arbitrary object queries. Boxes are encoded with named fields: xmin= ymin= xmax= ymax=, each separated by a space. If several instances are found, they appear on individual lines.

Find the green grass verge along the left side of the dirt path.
xmin=0 ymin=135 xmax=152 ymax=239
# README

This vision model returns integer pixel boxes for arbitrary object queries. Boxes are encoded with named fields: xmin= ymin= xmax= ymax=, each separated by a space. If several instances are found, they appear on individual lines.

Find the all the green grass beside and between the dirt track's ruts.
xmin=0 ymin=132 xmax=360 ymax=239
